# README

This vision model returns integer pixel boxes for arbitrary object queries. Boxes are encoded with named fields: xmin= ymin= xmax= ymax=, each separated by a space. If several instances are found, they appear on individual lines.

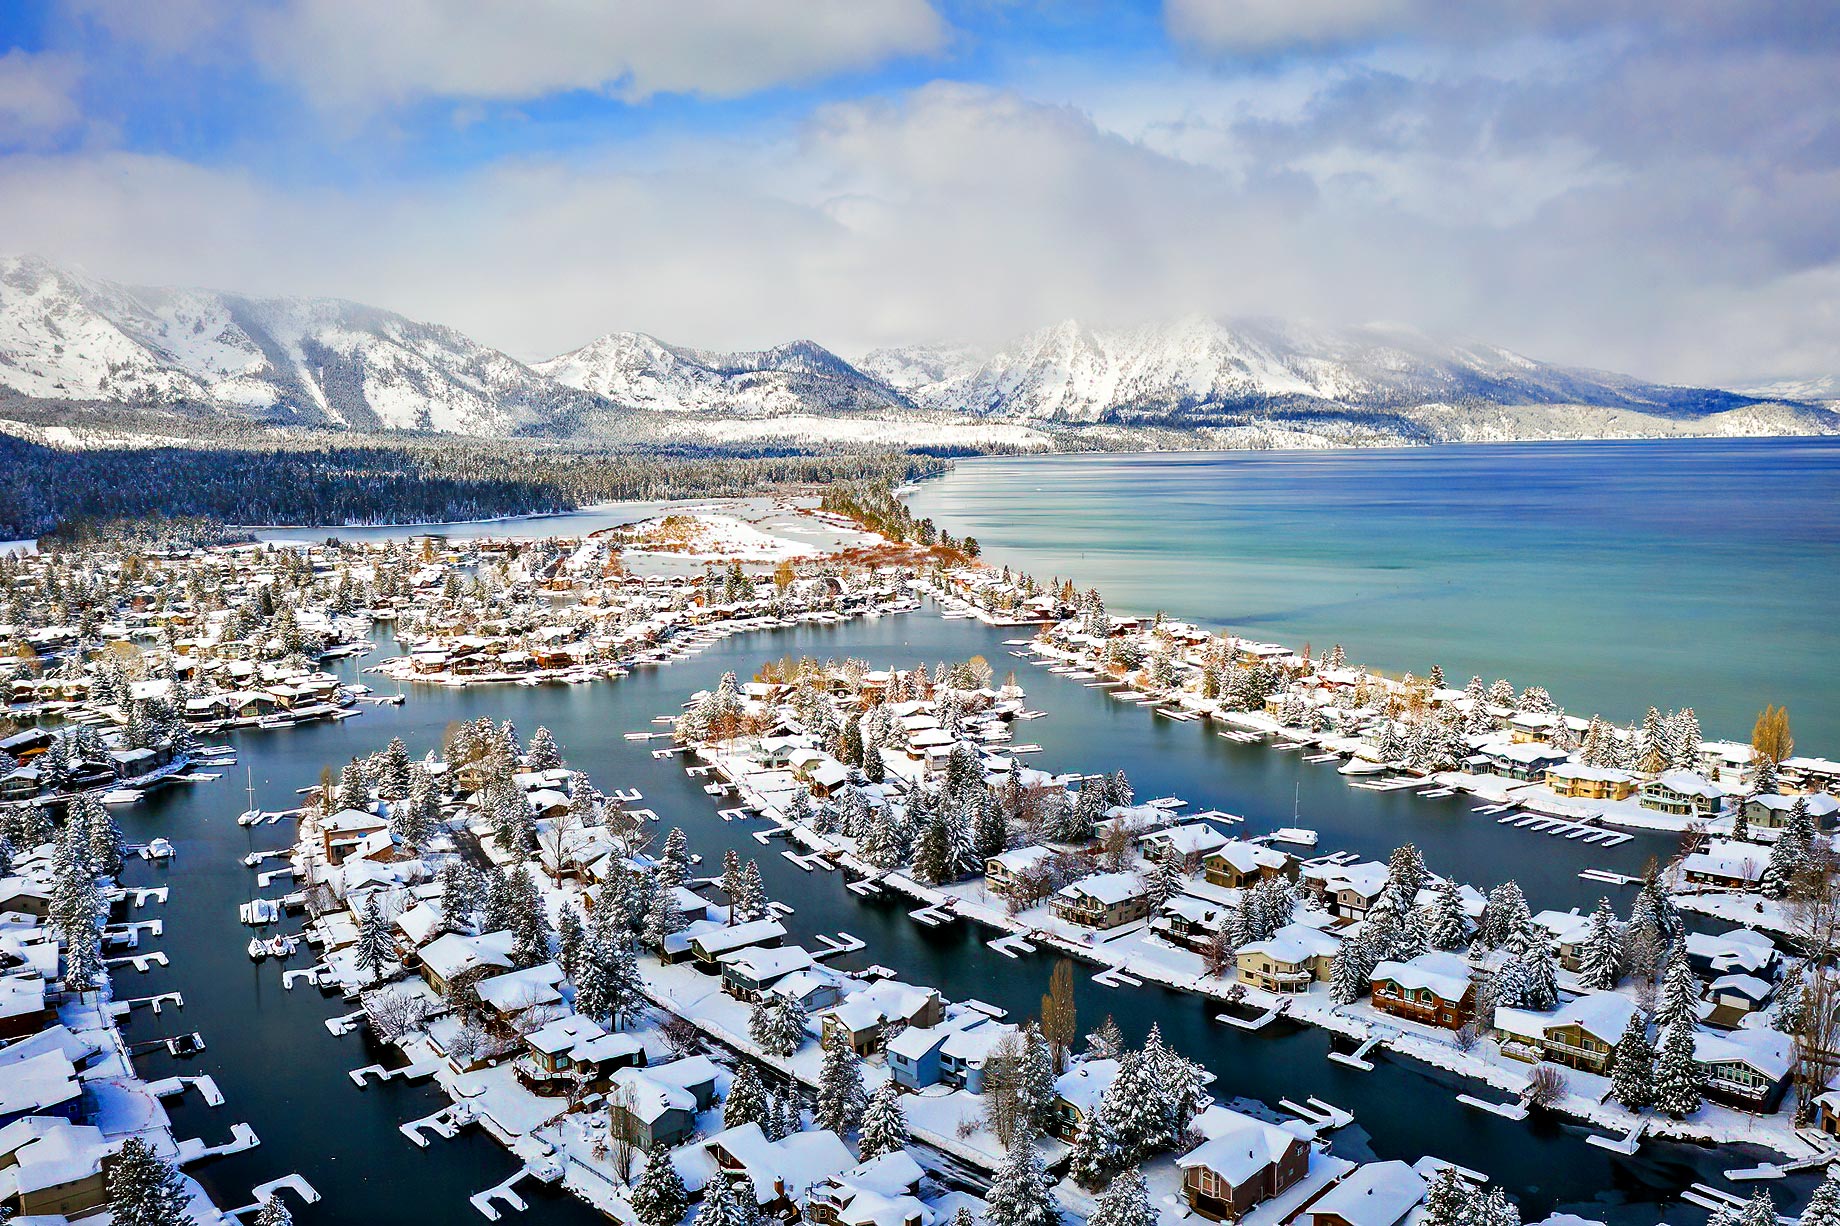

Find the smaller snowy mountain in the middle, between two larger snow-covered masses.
xmin=534 ymin=331 xmax=909 ymax=418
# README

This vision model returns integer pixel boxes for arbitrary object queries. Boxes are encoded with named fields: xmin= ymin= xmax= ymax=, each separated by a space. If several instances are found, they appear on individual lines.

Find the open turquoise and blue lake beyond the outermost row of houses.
xmin=911 ymin=438 xmax=1840 ymax=743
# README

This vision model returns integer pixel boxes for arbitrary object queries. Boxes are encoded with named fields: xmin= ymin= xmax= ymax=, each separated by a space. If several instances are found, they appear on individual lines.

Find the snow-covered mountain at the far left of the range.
xmin=0 ymin=258 xmax=599 ymax=434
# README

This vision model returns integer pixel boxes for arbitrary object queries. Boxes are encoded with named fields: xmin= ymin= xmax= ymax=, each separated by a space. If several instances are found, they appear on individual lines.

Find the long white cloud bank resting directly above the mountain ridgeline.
xmin=0 ymin=70 xmax=1840 ymax=381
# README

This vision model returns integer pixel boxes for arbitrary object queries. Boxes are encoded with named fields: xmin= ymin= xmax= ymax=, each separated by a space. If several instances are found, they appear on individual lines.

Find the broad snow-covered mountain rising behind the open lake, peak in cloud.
xmin=897 ymin=317 xmax=1773 ymax=427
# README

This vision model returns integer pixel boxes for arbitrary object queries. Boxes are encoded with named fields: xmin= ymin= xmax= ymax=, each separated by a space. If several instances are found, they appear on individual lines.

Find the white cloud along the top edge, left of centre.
xmin=66 ymin=0 xmax=948 ymax=112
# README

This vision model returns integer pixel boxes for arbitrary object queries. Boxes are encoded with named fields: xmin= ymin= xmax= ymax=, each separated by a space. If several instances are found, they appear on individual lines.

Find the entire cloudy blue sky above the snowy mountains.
xmin=0 ymin=0 xmax=1840 ymax=383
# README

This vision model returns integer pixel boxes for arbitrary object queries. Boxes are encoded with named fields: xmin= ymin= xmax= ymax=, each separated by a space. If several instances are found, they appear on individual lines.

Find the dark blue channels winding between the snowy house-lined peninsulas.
xmin=104 ymin=615 xmax=1805 ymax=1226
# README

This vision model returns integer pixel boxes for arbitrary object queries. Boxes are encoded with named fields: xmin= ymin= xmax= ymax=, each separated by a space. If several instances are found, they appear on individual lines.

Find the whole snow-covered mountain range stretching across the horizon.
xmin=0 ymin=258 xmax=1840 ymax=447
